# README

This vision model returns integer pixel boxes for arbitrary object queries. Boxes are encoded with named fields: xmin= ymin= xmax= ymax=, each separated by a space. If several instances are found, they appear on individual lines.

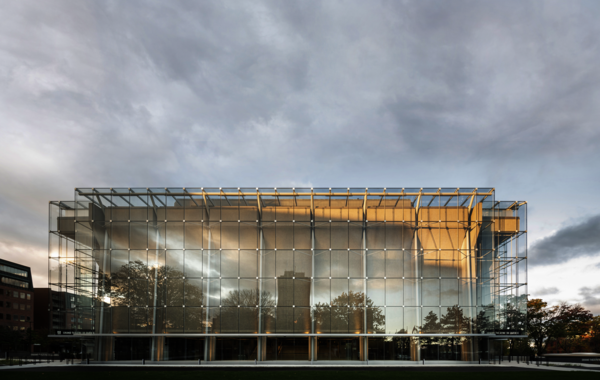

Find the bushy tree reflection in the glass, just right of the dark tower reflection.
xmin=313 ymin=291 xmax=385 ymax=333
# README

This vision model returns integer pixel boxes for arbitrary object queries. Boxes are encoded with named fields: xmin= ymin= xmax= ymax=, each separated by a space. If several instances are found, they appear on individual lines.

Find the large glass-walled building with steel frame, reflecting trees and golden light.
xmin=48 ymin=188 xmax=527 ymax=361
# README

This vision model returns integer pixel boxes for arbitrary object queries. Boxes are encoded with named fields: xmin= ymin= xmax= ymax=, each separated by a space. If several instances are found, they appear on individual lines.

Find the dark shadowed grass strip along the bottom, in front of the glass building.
xmin=0 ymin=366 xmax=599 ymax=380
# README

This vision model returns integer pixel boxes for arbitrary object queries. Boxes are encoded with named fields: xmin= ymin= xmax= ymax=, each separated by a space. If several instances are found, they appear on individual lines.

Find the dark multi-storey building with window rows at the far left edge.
xmin=0 ymin=259 xmax=34 ymax=331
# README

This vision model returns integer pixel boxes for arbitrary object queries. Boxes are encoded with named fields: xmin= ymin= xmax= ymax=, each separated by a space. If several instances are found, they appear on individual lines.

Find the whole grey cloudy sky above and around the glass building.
xmin=0 ymin=0 xmax=600 ymax=314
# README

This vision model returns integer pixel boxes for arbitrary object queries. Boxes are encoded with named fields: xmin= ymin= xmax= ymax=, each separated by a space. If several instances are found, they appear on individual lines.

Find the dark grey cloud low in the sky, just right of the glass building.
xmin=528 ymin=215 xmax=600 ymax=266
